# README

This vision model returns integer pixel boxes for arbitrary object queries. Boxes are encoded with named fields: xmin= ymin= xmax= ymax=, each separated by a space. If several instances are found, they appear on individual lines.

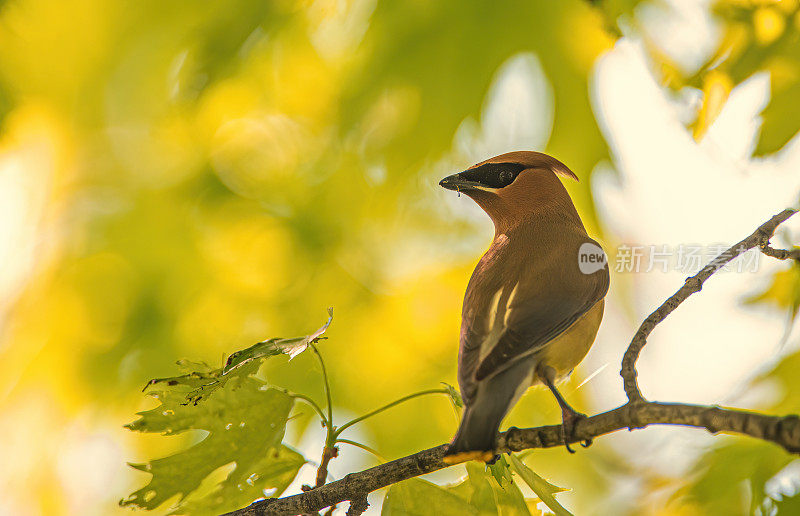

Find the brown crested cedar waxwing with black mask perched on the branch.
xmin=439 ymin=151 xmax=609 ymax=464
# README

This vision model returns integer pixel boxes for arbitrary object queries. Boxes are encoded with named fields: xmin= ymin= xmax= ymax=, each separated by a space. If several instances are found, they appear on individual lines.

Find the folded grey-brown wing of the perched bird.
xmin=464 ymin=240 xmax=609 ymax=382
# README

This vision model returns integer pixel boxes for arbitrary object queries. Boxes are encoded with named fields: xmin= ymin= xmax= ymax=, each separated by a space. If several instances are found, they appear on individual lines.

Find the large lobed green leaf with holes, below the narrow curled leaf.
xmin=120 ymin=377 xmax=305 ymax=514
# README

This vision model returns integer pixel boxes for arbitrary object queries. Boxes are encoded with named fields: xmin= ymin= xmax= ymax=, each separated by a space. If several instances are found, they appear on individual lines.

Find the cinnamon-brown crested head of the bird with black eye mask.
xmin=439 ymin=151 xmax=580 ymax=232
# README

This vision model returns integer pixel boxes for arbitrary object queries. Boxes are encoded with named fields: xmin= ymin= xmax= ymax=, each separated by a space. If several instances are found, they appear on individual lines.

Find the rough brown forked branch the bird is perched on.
xmin=225 ymin=209 xmax=800 ymax=516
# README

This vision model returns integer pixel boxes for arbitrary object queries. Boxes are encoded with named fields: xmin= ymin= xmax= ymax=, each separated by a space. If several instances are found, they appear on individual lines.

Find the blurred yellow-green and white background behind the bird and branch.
xmin=0 ymin=0 xmax=800 ymax=516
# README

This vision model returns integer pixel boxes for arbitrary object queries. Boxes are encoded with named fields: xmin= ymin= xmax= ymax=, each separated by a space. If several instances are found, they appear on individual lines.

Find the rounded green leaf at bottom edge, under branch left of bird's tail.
xmin=381 ymin=478 xmax=479 ymax=516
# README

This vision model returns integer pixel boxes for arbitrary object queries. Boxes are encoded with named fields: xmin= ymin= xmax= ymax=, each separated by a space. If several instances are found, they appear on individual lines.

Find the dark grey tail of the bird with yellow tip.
xmin=444 ymin=404 xmax=505 ymax=464
